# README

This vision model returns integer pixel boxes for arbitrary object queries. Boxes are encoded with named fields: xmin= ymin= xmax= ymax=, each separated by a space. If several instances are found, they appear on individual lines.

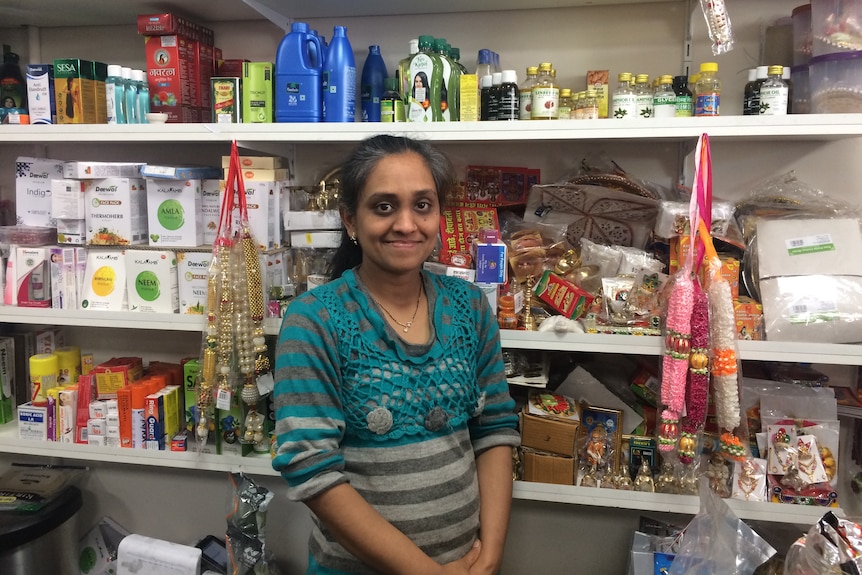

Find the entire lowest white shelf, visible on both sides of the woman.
xmin=0 ymin=424 xmax=842 ymax=525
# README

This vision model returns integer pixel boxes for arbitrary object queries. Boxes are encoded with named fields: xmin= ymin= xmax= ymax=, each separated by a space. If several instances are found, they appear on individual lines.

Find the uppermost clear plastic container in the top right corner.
xmin=811 ymin=0 xmax=862 ymax=57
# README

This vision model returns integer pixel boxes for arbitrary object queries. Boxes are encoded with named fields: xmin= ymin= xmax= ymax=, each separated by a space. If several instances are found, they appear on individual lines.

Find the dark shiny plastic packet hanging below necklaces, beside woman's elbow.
xmin=225 ymin=473 xmax=280 ymax=575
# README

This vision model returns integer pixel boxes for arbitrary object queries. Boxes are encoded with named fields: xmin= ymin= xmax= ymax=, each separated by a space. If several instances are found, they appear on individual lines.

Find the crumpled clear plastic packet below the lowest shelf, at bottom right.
xmin=668 ymin=481 xmax=775 ymax=575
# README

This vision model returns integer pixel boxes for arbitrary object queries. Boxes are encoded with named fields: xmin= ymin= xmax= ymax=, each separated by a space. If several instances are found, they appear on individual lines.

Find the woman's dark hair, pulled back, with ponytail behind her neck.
xmin=329 ymin=135 xmax=454 ymax=279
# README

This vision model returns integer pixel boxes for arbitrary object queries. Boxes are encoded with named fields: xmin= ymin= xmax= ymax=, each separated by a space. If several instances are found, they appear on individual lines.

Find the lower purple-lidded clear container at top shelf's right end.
xmin=808 ymin=50 xmax=862 ymax=114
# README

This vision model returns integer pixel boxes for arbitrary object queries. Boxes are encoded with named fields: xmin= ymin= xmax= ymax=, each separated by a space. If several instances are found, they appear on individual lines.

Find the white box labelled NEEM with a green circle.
xmin=125 ymin=250 xmax=179 ymax=313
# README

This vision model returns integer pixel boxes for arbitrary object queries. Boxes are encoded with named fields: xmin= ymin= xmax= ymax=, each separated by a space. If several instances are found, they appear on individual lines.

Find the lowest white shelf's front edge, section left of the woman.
xmin=0 ymin=423 xmax=278 ymax=476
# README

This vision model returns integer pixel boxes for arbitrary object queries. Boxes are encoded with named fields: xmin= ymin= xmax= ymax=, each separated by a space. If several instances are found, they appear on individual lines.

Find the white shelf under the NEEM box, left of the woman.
xmin=0 ymin=306 xmax=281 ymax=335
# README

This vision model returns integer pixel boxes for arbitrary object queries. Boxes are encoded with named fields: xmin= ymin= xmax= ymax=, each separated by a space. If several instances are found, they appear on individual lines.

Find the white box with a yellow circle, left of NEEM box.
xmin=80 ymin=250 xmax=129 ymax=311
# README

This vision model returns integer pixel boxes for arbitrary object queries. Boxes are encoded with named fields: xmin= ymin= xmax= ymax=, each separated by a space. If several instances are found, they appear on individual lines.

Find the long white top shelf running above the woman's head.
xmin=0 ymin=114 xmax=862 ymax=145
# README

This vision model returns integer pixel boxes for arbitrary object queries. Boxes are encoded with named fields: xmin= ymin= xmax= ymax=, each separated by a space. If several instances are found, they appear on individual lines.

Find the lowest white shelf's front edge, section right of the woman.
xmin=512 ymin=481 xmax=844 ymax=525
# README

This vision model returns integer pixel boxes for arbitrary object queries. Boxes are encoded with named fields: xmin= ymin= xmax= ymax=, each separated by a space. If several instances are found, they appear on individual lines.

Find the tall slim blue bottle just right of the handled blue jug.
xmin=323 ymin=26 xmax=356 ymax=122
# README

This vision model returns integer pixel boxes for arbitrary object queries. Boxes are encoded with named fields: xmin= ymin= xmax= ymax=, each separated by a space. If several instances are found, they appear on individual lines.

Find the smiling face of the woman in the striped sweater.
xmin=345 ymin=152 xmax=440 ymax=277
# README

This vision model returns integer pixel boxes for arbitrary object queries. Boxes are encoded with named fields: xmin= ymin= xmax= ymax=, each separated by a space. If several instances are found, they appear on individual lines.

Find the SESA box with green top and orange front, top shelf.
xmin=54 ymin=58 xmax=98 ymax=124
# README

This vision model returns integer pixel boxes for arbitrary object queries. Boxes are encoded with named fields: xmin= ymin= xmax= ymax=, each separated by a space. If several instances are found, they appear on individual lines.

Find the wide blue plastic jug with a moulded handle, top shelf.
xmin=275 ymin=22 xmax=323 ymax=122
